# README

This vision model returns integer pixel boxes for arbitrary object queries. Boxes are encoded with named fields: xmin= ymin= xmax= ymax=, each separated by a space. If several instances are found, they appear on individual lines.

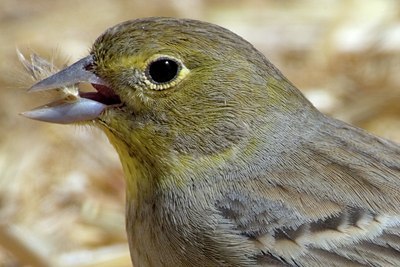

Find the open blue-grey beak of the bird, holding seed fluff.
xmin=22 ymin=55 xmax=120 ymax=124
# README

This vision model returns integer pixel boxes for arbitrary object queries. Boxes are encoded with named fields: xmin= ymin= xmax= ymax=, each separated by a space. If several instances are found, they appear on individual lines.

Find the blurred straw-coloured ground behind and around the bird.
xmin=0 ymin=0 xmax=400 ymax=267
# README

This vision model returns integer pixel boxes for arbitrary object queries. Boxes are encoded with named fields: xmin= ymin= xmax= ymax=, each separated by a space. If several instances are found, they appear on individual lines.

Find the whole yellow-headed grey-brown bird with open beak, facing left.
xmin=24 ymin=17 xmax=400 ymax=266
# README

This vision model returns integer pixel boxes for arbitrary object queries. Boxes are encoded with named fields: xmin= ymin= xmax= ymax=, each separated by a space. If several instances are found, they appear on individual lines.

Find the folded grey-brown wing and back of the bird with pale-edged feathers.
xmin=217 ymin=118 xmax=400 ymax=266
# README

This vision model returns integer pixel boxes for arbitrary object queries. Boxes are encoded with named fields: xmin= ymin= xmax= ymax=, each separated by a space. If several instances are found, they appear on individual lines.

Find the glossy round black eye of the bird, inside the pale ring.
xmin=149 ymin=59 xmax=179 ymax=83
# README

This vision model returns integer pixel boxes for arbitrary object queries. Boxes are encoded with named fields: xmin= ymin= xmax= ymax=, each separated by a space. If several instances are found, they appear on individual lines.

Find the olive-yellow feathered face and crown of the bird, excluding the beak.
xmin=90 ymin=19 xmax=276 ymax=161
